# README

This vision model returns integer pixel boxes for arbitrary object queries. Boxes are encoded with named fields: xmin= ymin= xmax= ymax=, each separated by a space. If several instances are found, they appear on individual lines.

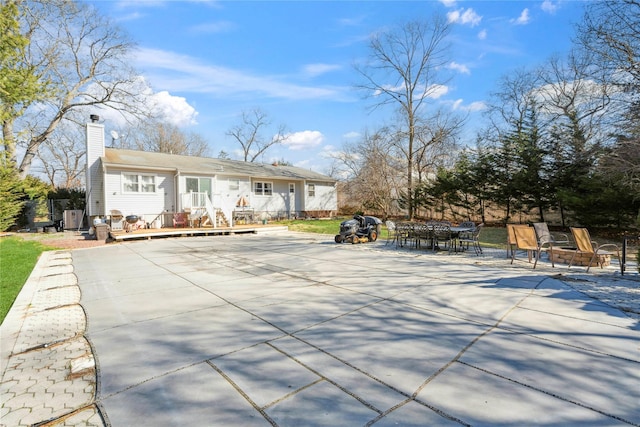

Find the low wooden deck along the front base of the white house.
xmin=109 ymin=224 xmax=288 ymax=242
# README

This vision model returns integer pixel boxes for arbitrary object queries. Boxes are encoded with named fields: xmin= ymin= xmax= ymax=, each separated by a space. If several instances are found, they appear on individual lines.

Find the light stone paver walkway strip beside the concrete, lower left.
xmin=0 ymin=251 xmax=104 ymax=427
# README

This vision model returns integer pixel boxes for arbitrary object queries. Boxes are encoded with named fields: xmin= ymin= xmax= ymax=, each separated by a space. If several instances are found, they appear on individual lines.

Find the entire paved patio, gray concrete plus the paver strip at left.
xmin=0 ymin=232 xmax=640 ymax=427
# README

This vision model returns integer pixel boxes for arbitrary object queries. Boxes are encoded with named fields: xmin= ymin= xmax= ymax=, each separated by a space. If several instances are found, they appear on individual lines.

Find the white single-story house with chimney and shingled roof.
xmin=86 ymin=122 xmax=338 ymax=227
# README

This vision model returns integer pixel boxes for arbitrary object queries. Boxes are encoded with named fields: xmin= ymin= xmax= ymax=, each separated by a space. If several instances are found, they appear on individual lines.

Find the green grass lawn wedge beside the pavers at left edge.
xmin=0 ymin=237 xmax=54 ymax=323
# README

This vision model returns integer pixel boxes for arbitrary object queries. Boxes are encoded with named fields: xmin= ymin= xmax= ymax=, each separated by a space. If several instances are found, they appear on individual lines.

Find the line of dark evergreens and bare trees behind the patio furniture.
xmin=336 ymin=0 xmax=640 ymax=229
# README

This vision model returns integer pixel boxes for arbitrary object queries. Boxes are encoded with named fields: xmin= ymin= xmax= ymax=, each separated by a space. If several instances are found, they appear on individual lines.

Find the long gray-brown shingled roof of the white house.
xmin=102 ymin=148 xmax=336 ymax=182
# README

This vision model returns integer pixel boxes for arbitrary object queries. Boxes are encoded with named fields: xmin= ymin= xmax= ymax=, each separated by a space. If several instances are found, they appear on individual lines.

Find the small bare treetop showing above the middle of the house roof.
xmin=227 ymin=108 xmax=288 ymax=162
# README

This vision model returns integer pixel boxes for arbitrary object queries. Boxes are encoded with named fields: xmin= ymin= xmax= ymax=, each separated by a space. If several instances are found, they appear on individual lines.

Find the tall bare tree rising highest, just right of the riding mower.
xmin=356 ymin=15 xmax=450 ymax=218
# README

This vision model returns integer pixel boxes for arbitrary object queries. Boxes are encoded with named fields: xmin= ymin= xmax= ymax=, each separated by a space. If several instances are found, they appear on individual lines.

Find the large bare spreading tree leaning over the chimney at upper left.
xmin=2 ymin=0 xmax=144 ymax=178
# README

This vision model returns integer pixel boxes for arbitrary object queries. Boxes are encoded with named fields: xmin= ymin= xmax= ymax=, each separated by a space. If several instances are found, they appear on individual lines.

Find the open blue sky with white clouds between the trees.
xmin=91 ymin=0 xmax=584 ymax=172
